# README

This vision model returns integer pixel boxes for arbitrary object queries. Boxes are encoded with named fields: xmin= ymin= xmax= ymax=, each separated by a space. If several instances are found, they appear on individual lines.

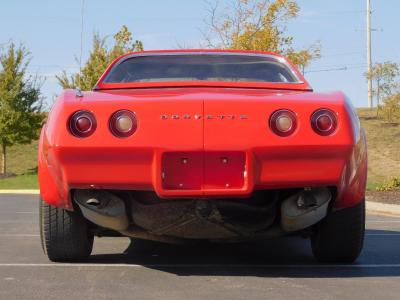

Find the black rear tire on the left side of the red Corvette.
xmin=40 ymin=200 xmax=94 ymax=262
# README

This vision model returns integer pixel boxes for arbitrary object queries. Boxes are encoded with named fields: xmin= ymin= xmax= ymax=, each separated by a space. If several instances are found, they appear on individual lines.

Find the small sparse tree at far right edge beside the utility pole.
xmin=364 ymin=61 xmax=400 ymax=108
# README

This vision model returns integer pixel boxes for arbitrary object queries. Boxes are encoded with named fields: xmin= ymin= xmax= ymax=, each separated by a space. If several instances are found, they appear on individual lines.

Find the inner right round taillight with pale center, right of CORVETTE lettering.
xmin=269 ymin=109 xmax=297 ymax=136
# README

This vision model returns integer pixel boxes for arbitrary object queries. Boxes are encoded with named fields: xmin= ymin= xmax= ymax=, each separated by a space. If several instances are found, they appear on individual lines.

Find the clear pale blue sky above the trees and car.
xmin=0 ymin=0 xmax=400 ymax=107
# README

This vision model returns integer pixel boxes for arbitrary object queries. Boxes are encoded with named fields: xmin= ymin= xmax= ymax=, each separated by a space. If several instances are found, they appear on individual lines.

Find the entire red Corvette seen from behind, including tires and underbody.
xmin=39 ymin=50 xmax=367 ymax=262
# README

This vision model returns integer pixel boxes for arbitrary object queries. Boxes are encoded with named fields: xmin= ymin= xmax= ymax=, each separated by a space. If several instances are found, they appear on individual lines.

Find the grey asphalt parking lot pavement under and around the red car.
xmin=0 ymin=195 xmax=400 ymax=300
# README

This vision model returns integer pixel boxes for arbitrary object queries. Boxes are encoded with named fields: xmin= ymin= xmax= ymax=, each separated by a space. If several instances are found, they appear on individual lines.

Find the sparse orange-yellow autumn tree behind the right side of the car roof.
xmin=204 ymin=0 xmax=320 ymax=69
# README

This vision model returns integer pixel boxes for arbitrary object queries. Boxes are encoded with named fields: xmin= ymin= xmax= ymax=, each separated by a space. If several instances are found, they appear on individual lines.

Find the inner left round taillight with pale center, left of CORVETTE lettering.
xmin=110 ymin=109 xmax=137 ymax=138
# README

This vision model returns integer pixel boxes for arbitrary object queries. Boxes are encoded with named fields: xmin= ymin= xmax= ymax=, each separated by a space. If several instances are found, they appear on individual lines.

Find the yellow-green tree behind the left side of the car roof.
xmin=56 ymin=25 xmax=143 ymax=90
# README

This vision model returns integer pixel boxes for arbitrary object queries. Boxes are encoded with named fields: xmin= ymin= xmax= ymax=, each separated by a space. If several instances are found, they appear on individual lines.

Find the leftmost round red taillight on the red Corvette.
xmin=69 ymin=110 xmax=97 ymax=138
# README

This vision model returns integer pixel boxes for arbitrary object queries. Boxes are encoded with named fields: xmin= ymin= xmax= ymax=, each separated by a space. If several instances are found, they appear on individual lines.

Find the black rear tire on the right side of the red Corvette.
xmin=311 ymin=199 xmax=365 ymax=263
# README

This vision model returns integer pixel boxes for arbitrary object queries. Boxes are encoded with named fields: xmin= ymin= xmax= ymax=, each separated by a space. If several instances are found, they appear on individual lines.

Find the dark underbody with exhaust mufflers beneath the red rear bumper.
xmin=72 ymin=188 xmax=336 ymax=243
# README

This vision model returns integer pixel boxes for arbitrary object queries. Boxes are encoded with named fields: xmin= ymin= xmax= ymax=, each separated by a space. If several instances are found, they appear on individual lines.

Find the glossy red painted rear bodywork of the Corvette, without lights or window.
xmin=39 ymin=50 xmax=367 ymax=209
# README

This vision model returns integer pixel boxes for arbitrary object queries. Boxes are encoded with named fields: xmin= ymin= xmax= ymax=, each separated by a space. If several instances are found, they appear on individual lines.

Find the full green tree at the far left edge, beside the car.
xmin=0 ymin=43 xmax=44 ymax=174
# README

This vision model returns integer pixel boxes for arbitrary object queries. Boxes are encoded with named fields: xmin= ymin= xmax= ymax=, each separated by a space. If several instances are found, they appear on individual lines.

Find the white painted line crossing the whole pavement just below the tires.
xmin=0 ymin=263 xmax=400 ymax=269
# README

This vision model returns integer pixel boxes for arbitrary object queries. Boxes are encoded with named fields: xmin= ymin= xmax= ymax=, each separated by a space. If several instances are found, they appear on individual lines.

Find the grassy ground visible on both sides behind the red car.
xmin=0 ymin=108 xmax=400 ymax=190
